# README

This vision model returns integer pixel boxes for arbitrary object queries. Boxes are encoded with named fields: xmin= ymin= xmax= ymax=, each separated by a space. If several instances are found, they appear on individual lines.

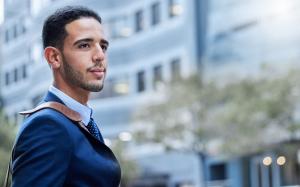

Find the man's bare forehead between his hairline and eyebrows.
xmin=65 ymin=18 xmax=104 ymax=40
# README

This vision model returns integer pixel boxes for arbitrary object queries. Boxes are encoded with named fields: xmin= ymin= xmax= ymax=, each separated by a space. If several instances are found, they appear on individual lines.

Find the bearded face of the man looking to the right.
xmin=60 ymin=18 xmax=108 ymax=92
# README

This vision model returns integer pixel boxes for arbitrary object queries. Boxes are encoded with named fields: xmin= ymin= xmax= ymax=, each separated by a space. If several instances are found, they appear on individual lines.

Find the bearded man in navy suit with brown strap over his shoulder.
xmin=12 ymin=7 xmax=121 ymax=187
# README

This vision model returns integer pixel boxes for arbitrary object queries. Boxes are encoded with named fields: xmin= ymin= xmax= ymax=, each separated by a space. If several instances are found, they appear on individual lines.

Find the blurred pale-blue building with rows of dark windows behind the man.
xmin=1 ymin=0 xmax=207 ymax=186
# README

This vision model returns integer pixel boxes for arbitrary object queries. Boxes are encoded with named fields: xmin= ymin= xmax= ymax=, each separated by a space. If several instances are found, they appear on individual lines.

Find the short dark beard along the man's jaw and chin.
xmin=61 ymin=55 xmax=104 ymax=92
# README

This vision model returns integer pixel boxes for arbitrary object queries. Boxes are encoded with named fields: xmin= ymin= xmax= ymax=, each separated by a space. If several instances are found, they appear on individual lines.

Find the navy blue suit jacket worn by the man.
xmin=12 ymin=92 xmax=121 ymax=187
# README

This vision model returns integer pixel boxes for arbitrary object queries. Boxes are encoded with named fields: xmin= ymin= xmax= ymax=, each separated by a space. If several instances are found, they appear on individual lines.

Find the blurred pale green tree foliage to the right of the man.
xmin=134 ymin=70 xmax=300 ymax=154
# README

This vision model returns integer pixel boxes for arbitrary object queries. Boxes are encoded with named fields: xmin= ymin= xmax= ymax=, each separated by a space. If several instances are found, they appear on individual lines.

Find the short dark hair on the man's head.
xmin=42 ymin=6 xmax=102 ymax=49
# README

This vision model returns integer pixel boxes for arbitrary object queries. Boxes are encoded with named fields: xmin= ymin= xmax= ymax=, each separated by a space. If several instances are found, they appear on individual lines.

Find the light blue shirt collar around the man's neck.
xmin=49 ymin=85 xmax=92 ymax=125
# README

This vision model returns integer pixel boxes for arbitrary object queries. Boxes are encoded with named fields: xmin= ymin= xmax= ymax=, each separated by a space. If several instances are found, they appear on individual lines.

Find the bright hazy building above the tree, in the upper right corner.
xmin=205 ymin=0 xmax=300 ymax=76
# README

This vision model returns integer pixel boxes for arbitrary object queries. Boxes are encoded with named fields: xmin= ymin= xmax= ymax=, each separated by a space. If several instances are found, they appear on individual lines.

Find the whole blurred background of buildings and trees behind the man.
xmin=0 ymin=0 xmax=300 ymax=187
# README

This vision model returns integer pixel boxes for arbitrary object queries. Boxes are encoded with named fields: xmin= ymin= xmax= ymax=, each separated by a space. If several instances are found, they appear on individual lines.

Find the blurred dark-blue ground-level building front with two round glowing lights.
xmin=204 ymin=141 xmax=300 ymax=187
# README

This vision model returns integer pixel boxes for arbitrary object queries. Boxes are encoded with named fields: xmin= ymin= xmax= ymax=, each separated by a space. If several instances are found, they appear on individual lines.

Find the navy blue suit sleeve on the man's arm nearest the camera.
xmin=12 ymin=112 xmax=73 ymax=187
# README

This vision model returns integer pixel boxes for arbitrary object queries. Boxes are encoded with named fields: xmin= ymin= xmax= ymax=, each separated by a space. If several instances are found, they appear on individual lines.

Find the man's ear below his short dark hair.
xmin=44 ymin=46 xmax=62 ymax=69
